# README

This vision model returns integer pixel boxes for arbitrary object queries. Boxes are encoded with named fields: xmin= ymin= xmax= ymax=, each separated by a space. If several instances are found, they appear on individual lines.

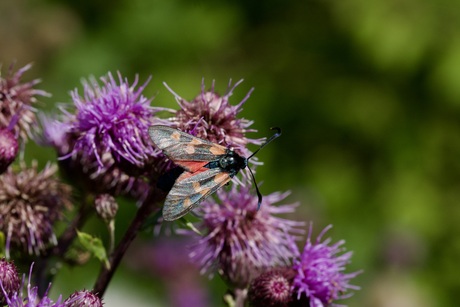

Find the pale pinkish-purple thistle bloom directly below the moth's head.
xmin=185 ymin=180 xmax=303 ymax=287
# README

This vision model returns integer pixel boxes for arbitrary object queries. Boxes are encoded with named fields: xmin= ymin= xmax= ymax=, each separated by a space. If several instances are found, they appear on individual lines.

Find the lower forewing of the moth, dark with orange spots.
xmin=163 ymin=168 xmax=230 ymax=221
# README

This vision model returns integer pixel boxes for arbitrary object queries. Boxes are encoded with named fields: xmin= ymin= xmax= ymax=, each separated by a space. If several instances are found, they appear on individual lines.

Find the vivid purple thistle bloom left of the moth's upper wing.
xmin=63 ymin=73 xmax=158 ymax=169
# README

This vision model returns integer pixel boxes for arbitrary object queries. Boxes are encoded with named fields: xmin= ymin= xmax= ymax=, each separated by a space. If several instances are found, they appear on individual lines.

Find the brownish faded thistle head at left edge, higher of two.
xmin=0 ymin=64 xmax=50 ymax=141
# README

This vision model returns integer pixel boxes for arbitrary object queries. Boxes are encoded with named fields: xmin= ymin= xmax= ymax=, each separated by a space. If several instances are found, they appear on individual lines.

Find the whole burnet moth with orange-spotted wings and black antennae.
xmin=149 ymin=125 xmax=281 ymax=221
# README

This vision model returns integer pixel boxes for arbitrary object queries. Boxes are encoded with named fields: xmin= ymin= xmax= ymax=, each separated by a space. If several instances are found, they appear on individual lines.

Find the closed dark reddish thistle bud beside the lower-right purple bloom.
xmin=248 ymin=267 xmax=295 ymax=307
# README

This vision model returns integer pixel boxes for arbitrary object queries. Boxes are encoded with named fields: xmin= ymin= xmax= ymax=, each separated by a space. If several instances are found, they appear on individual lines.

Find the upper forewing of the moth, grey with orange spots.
xmin=149 ymin=125 xmax=227 ymax=166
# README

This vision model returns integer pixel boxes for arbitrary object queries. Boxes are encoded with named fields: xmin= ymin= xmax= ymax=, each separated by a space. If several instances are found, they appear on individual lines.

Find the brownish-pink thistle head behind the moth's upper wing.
xmin=164 ymin=80 xmax=263 ymax=156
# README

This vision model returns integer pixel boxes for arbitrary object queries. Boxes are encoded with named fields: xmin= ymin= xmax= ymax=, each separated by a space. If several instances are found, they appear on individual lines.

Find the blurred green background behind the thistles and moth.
xmin=0 ymin=0 xmax=460 ymax=307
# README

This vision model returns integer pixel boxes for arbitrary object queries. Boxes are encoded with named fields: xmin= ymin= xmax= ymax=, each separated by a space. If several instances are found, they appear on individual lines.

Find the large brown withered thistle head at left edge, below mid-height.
xmin=0 ymin=161 xmax=71 ymax=257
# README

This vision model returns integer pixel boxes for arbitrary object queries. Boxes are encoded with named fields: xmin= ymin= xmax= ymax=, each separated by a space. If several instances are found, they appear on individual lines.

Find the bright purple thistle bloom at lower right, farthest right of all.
xmin=293 ymin=225 xmax=361 ymax=307
